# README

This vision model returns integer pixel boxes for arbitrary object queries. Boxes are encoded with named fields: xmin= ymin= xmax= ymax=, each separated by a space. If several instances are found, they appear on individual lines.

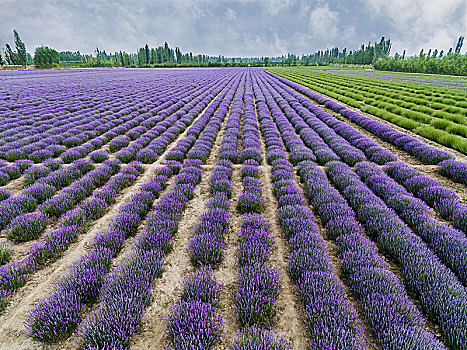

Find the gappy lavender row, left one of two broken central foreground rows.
xmin=166 ymin=160 xmax=232 ymax=349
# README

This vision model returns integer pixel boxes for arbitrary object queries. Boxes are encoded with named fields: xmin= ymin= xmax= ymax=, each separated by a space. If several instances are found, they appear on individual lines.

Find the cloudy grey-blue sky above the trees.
xmin=0 ymin=0 xmax=467 ymax=57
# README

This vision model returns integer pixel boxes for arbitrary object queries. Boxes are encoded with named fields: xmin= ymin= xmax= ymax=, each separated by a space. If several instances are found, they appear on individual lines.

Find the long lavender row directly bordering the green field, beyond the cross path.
xmin=268 ymin=72 xmax=455 ymax=164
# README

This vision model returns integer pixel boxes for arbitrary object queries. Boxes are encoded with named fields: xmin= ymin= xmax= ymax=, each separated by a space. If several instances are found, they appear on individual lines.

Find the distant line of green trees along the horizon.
xmin=0 ymin=30 xmax=467 ymax=75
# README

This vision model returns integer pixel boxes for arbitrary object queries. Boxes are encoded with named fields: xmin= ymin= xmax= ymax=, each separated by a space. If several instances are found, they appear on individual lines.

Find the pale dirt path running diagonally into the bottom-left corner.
xmin=0 ymin=85 xmax=229 ymax=350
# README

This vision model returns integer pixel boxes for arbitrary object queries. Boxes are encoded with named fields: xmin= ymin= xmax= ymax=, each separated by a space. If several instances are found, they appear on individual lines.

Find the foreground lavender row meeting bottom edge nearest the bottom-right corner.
xmin=299 ymin=162 xmax=445 ymax=349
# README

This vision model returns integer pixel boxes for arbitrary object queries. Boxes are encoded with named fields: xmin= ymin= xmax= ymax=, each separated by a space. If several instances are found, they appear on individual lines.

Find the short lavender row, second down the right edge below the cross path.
xmin=384 ymin=162 xmax=467 ymax=233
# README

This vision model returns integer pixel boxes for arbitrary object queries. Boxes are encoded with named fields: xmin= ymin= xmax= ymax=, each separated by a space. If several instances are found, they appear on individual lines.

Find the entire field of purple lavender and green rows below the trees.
xmin=0 ymin=67 xmax=467 ymax=350
